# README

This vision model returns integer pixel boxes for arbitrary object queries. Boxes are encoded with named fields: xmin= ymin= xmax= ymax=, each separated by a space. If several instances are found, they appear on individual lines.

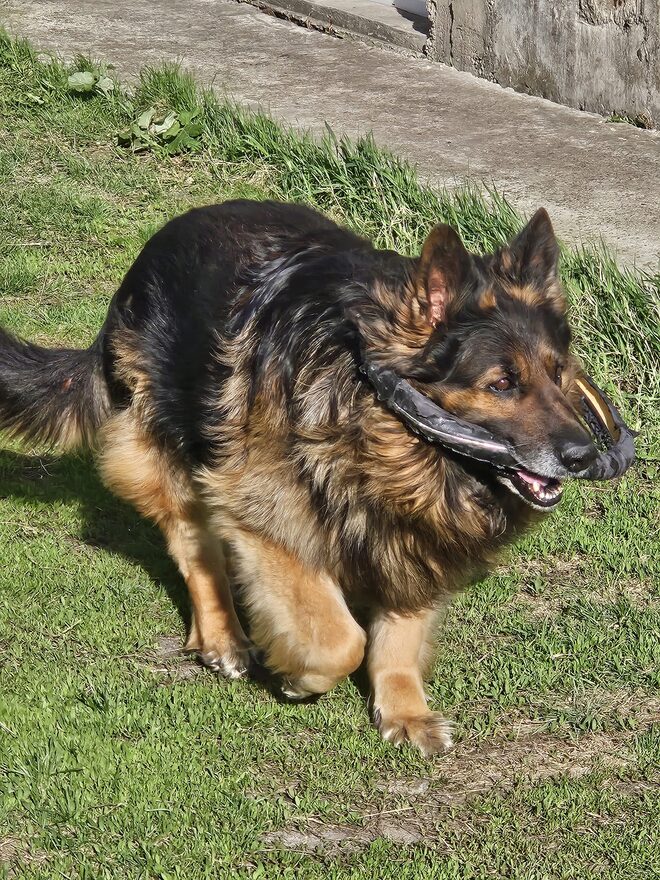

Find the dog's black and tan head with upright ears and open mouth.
xmin=390 ymin=210 xmax=598 ymax=510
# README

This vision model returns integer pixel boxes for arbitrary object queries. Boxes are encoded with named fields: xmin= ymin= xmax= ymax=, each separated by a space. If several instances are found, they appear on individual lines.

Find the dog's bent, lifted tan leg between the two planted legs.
xmin=231 ymin=532 xmax=366 ymax=699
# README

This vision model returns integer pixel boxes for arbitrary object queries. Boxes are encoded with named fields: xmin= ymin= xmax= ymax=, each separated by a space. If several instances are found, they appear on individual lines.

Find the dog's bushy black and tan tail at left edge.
xmin=0 ymin=328 xmax=110 ymax=449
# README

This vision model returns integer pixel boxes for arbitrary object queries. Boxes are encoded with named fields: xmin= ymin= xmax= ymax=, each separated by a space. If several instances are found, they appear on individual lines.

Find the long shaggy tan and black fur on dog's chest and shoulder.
xmin=206 ymin=359 xmax=529 ymax=611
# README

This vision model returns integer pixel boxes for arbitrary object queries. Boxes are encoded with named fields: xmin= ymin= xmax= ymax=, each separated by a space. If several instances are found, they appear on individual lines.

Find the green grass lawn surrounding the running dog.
xmin=0 ymin=38 xmax=660 ymax=880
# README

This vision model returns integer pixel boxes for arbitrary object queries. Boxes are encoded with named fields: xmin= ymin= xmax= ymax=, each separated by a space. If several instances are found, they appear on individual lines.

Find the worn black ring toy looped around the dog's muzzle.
xmin=360 ymin=361 xmax=636 ymax=480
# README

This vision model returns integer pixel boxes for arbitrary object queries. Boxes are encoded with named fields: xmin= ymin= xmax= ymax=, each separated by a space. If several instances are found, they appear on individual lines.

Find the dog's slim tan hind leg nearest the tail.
xmin=99 ymin=409 xmax=249 ymax=678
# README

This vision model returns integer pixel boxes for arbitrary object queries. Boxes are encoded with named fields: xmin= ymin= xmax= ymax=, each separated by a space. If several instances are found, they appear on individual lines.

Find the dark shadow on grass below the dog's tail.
xmin=0 ymin=450 xmax=191 ymax=630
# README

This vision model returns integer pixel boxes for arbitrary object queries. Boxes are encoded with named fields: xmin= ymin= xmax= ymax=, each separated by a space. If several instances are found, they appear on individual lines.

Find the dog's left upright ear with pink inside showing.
xmin=415 ymin=223 xmax=476 ymax=327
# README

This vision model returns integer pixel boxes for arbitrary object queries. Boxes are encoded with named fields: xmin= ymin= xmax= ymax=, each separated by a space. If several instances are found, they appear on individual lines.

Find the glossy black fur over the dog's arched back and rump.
xmin=101 ymin=201 xmax=370 ymax=463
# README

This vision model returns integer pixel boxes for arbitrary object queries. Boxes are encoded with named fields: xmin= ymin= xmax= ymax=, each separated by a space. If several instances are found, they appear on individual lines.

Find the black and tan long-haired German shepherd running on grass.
xmin=0 ymin=201 xmax=597 ymax=754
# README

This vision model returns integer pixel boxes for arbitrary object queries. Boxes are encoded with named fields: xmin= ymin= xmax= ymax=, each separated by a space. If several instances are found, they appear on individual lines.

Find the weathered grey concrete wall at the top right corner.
xmin=426 ymin=0 xmax=660 ymax=128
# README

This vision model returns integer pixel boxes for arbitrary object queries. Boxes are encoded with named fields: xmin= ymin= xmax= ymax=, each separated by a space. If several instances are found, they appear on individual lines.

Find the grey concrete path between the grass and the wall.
xmin=0 ymin=0 xmax=660 ymax=269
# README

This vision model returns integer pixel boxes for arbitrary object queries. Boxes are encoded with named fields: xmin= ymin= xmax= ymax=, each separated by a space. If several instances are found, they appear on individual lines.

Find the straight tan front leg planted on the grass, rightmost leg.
xmin=367 ymin=610 xmax=452 ymax=755
